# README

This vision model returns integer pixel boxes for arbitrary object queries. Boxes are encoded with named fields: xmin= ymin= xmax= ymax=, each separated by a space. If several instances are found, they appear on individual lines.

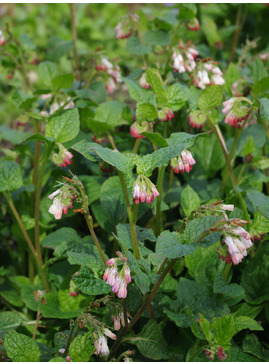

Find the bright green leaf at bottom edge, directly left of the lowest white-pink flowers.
xmin=69 ymin=332 xmax=95 ymax=362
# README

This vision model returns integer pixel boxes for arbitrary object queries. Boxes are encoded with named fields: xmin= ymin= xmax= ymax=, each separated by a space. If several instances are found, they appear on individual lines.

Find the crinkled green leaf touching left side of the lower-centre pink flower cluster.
xmin=73 ymin=267 xmax=111 ymax=296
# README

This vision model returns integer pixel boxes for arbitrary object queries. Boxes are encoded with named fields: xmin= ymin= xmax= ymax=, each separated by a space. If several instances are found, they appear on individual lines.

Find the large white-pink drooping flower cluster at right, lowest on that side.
xmin=217 ymin=218 xmax=252 ymax=265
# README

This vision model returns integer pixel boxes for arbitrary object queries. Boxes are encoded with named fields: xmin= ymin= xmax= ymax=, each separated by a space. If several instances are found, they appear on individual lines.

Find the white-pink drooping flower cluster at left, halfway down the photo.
xmin=49 ymin=183 xmax=78 ymax=220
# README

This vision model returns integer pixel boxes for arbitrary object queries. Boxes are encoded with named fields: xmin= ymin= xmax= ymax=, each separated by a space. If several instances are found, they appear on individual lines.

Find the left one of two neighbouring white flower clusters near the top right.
xmin=172 ymin=43 xmax=198 ymax=73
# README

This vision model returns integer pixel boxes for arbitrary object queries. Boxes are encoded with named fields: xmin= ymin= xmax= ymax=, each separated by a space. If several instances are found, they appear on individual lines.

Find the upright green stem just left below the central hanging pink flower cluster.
xmin=118 ymin=170 xmax=141 ymax=259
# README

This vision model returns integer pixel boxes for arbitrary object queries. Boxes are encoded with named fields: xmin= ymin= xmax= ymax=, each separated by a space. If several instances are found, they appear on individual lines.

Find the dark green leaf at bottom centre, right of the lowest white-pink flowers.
xmin=128 ymin=320 xmax=167 ymax=360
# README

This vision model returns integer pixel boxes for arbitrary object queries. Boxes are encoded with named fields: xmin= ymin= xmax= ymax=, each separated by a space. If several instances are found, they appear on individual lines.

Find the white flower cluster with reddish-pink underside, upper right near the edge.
xmin=222 ymin=97 xmax=250 ymax=128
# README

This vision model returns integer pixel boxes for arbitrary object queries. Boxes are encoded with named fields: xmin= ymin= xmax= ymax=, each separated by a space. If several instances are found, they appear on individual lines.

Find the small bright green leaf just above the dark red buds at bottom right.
xmin=212 ymin=315 xmax=234 ymax=346
